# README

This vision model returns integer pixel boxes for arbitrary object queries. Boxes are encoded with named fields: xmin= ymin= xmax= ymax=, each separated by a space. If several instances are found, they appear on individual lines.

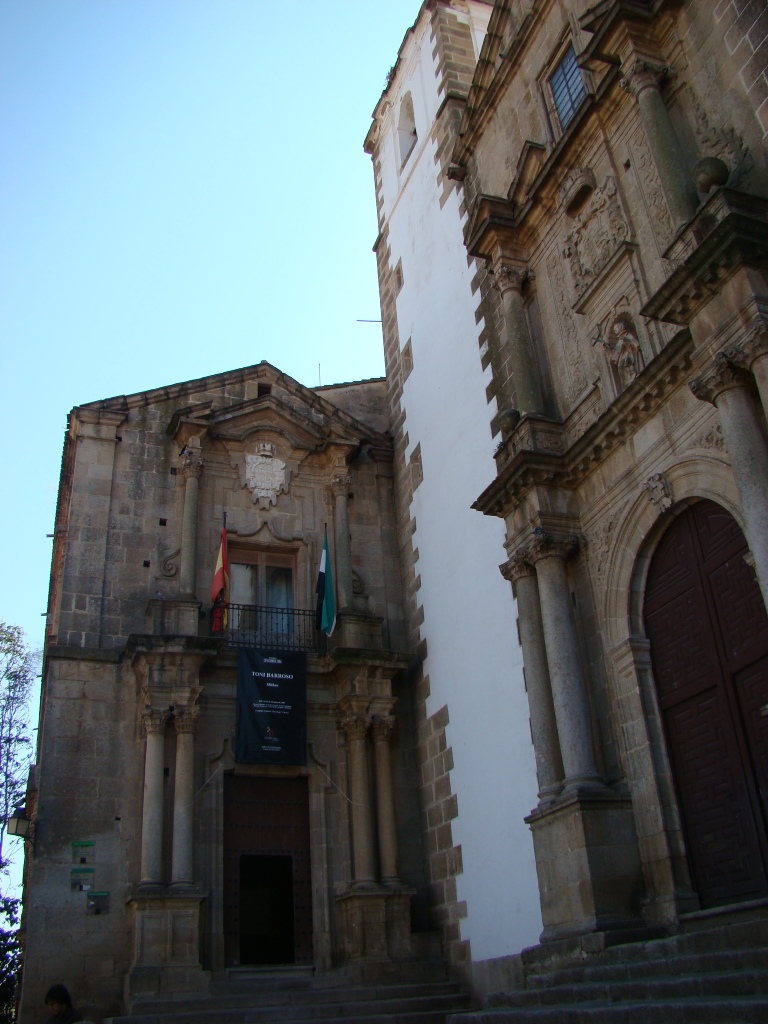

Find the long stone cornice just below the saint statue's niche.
xmin=479 ymin=331 xmax=693 ymax=518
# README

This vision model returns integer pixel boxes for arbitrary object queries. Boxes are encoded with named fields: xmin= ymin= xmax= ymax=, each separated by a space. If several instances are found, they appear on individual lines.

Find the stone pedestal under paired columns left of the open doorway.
xmin=124 ymin=888 xmax=211 ymax=1010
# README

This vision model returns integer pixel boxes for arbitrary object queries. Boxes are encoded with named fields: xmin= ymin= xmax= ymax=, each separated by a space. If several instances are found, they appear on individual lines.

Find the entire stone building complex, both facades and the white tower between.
xmin=22 ymin=0 xmax=768 ymax=1024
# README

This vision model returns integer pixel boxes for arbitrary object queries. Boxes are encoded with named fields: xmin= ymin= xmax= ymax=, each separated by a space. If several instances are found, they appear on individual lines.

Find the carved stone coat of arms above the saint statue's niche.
xmin=563 ymin=174 xmax=630 ymax=297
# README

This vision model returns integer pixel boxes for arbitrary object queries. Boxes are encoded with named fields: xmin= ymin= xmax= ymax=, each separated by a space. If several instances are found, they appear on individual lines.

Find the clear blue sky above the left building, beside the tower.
xmin=0 ymin=0 xmax=420 ymax=645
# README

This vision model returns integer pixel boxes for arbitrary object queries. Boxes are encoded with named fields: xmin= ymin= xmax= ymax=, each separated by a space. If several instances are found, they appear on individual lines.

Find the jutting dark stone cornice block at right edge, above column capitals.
xmin=640 ymin=188 xmax=768 ymax=327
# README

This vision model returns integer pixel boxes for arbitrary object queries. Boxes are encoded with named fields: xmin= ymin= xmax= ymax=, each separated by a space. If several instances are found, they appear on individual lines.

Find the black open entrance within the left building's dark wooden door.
xmin=240 ymin=854 xmax=295 ymax=964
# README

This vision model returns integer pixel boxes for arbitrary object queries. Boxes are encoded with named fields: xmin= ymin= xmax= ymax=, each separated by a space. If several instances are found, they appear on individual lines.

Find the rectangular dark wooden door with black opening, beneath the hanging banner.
xmin=224 ymin=774 xmax=312 ymax=967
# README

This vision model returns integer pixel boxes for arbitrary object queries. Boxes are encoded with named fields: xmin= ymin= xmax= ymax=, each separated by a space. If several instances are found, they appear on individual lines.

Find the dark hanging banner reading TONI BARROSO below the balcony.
xmin=234 ymin=649 xmax=306 ymax=765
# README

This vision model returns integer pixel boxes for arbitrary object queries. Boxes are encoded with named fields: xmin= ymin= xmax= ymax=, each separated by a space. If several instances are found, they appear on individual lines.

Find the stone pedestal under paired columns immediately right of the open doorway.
xmin=336 ymin=886 xmax=416 ymax=964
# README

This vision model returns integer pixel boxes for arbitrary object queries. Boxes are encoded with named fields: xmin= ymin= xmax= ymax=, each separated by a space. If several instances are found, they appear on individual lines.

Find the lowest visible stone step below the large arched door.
xmin=446 ymin=995 xmax=768 ymax=1024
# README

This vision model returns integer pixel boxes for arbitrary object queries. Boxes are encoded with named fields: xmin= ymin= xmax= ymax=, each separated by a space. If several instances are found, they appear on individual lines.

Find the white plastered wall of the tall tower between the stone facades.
xmin=380 ymin=5 xmax=542 ymax=961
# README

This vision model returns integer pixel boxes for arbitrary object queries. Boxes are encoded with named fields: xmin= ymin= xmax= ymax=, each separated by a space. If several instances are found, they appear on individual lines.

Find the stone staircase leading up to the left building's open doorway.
xmin=103 ymin=970 xmax=470 ymax=1024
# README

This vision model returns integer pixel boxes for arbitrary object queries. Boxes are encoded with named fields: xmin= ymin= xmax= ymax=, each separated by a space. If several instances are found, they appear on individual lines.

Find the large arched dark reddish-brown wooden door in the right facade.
xmin=644 ymin=501 xmax=768 ymax=906
